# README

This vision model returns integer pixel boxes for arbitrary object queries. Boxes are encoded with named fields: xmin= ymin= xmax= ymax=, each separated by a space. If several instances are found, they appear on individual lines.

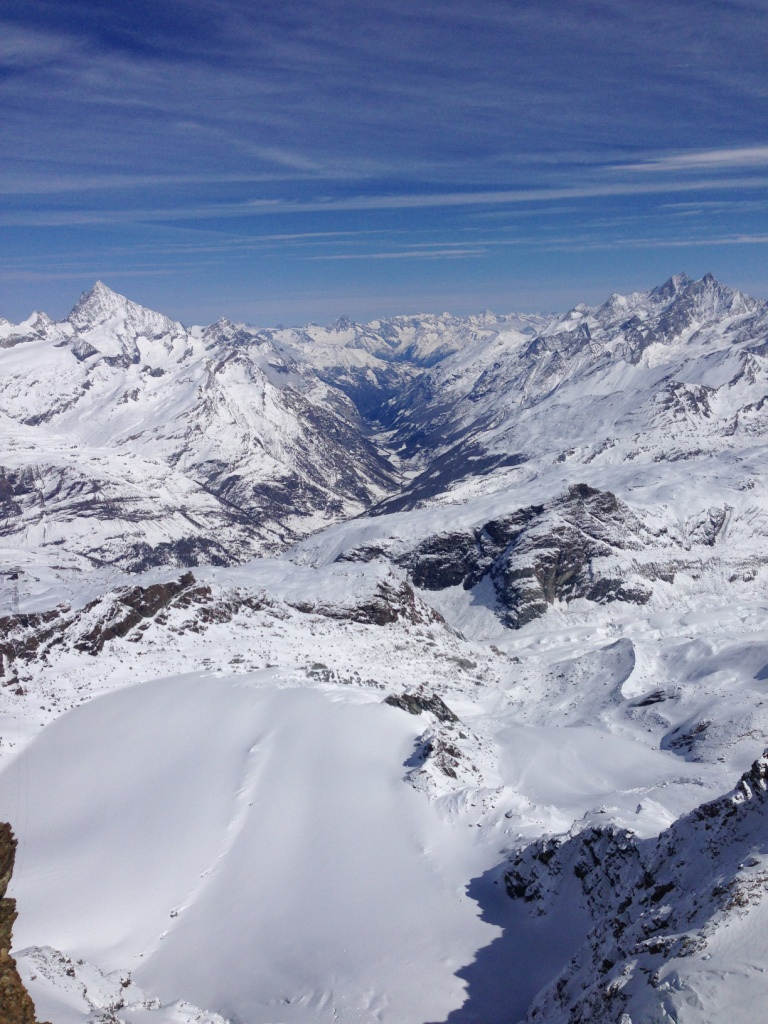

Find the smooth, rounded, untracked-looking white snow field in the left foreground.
xmin=0 ymin=675 xmax=495 ymax=1024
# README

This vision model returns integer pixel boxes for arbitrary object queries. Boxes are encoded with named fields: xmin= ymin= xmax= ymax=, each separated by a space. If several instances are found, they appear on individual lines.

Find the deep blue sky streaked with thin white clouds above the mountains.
xmin=0 ymin=0 xmax=768 ymax=325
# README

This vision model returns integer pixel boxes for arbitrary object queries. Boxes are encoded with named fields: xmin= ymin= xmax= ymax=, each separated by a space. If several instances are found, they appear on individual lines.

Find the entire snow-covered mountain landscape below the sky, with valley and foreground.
xmin=0 ymin=274 xmax=768 ymax=1024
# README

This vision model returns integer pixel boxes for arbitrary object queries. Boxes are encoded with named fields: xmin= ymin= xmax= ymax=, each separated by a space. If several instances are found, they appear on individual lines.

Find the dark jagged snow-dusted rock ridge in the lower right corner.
xmin=504 ymin=752 xmax=768 ymax=1024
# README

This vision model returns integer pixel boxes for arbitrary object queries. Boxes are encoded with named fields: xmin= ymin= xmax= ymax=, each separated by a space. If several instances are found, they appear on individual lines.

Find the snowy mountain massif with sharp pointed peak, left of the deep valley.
xmin=0 ymin=283 xmax=394 ymax=568
